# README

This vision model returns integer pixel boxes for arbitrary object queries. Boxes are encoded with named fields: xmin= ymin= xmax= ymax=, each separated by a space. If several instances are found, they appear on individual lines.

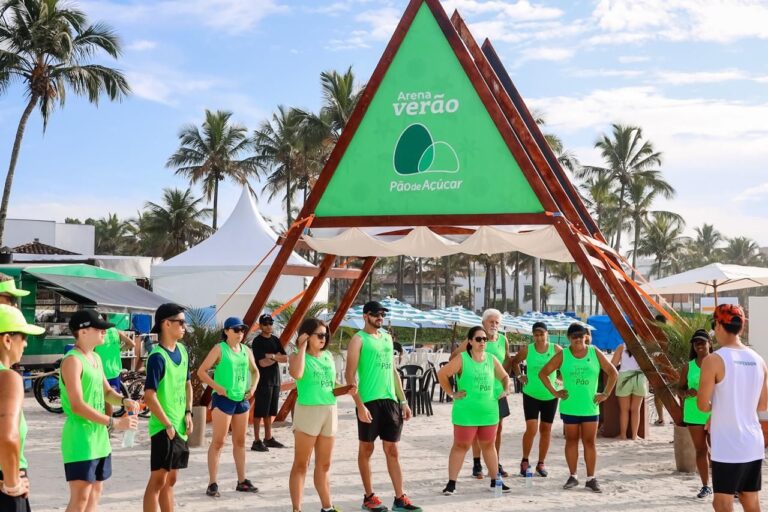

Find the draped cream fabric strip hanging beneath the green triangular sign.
xmin=304 ymin=226 xmax=573 ymax=262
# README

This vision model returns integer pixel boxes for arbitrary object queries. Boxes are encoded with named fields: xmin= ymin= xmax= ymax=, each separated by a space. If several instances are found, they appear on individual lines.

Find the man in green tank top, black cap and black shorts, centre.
xmin=345 ymin=301 xmax=421 ymax=512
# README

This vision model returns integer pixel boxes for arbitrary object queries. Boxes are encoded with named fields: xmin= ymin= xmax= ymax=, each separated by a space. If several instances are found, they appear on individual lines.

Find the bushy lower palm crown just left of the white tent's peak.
xmin=145 ymin=188 xmax=213 ymax=259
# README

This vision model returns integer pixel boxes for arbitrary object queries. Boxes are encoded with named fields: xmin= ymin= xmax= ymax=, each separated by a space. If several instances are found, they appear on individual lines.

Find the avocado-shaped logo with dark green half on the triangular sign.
xmin=392 ymin=123 xmax=459 ymax=176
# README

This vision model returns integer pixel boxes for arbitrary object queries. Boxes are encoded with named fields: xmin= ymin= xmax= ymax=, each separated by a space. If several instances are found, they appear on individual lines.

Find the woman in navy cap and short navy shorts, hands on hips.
xmin=197 ymin=316 xmax=259 ymax=498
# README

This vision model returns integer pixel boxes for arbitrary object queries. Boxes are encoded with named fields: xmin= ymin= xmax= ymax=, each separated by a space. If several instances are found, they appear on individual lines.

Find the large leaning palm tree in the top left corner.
xmin=0 ymin=0 xmax=130 ymax=246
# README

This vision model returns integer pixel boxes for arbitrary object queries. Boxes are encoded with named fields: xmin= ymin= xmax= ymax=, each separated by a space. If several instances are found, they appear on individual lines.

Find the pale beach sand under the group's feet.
xmin=24 ymin=393 xmax=768 ymax=512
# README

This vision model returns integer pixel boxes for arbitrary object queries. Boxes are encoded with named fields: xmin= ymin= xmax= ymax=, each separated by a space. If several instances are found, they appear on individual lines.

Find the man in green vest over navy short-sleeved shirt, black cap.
xmin=144 ymin=303 xmax=192 ymax=512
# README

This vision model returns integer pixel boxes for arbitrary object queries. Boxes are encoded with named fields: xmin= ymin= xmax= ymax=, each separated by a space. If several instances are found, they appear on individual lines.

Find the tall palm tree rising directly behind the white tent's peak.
xmin=165 ymin=109 xmax=256 ymax=231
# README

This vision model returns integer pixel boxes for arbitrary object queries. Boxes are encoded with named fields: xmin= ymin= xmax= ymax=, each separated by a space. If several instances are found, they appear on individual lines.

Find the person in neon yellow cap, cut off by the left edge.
xmin=0 ymin=304 xmax=45 ymax=512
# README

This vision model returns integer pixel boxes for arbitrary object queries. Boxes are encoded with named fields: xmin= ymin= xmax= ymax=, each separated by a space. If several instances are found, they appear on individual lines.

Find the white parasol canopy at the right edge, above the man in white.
xmin=643 ymin=263 xmax=768 ymax=295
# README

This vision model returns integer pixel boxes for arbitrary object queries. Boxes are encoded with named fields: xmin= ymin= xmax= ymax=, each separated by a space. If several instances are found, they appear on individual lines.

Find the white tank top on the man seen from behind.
xmin=710 ymin=347 xmax=765 ymax=463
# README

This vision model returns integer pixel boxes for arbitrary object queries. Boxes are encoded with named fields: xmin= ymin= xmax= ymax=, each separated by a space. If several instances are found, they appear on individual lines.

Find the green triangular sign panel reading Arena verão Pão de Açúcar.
xmin=315 ymin=3 xmax=544 ymax=217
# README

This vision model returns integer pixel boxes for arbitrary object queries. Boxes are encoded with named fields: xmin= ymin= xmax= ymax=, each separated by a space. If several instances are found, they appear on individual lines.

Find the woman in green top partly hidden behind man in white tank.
xmin=679 ymin=329 xmax=712 ymax=498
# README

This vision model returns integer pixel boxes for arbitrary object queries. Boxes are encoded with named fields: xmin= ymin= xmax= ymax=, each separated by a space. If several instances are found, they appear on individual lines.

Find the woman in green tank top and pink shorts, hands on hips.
xmin=437 ymin=326 xmax=509 ymax=496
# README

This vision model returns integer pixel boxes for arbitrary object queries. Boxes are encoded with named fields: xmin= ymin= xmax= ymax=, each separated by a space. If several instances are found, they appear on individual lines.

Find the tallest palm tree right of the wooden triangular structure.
xmin=579 ymin=124 xmax=661 ymax=251
